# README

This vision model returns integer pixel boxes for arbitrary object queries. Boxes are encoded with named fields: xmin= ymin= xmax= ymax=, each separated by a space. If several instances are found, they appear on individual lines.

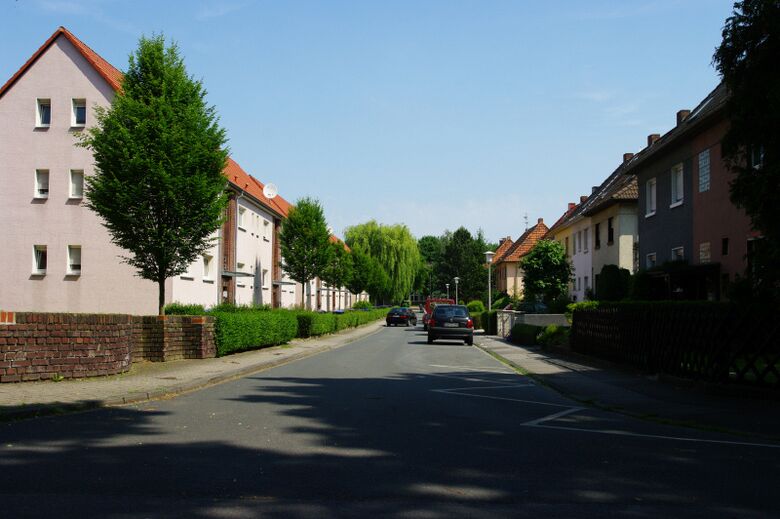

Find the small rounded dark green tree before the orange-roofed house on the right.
xmin=520 ymin=240 xmax=572 ymax=304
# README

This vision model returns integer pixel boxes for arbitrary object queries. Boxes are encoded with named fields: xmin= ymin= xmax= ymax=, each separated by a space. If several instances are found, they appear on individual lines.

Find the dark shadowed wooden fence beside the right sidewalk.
xmin=570 ymin=303 xmax=780 ymax=388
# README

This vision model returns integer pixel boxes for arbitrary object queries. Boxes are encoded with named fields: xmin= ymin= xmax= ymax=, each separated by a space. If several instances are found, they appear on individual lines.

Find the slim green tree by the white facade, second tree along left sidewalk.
xmin=279 ymin=198 xmax=333 ymax=310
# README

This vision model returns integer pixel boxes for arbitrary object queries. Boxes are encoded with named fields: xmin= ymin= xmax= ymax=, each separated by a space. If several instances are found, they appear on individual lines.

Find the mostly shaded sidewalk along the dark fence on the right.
xmin=478 ymin=336 xmax=780 ymax=440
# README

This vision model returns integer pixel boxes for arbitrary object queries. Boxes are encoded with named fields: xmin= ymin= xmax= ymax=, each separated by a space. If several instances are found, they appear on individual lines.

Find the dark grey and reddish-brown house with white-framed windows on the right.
xmin=625 ymin=84 xmax=757 ymax=299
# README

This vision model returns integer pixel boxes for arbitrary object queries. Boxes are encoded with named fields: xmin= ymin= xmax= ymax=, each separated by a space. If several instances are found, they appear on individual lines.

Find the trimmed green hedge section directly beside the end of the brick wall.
xmin=210 ymin=309 xmax=298 ymax=356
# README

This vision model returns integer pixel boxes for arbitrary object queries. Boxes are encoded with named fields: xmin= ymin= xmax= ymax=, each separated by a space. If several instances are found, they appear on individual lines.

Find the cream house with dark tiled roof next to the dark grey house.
xmin=545 ymin=157 xmax=638 ymax=301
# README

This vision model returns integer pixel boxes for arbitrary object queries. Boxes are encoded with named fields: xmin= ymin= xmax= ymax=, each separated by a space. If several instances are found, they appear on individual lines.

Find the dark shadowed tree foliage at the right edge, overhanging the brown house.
xmin=713 ymin=0 xmax=780 ymax=297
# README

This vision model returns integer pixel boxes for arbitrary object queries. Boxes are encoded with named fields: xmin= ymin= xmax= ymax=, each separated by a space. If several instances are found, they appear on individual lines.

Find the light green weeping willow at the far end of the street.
xmin=345 ymin=220 xmax=421 ymax=302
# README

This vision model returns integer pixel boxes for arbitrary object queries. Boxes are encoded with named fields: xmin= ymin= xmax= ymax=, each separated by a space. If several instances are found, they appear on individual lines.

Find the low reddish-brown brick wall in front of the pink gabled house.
xmin=0 ymin=311 xmax=216 ymax=382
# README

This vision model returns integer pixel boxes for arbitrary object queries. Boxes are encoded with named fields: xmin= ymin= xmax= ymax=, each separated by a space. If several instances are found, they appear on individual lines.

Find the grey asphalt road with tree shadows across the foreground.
xmin=0 ymin=327 xmax=780 ymax=519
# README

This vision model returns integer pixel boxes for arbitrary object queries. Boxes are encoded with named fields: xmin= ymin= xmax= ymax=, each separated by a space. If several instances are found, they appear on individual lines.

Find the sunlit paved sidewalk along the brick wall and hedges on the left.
xmin=0 ymin=320 xmax=384 ymax=420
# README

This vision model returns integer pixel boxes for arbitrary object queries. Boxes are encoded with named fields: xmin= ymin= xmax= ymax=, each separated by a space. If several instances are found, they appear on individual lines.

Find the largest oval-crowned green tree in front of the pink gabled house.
xmin=81 ymin=36 xmax=228 ymax=315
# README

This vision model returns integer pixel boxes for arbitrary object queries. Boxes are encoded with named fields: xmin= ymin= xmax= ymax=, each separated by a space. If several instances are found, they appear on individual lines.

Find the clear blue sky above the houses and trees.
xmin=0 ymin=0 xmax=732 ymax=244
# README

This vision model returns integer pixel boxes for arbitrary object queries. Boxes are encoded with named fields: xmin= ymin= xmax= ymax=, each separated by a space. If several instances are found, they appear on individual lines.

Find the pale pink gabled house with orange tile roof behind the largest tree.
xmin=0 ymin=27 xmax=354 ymax=314
